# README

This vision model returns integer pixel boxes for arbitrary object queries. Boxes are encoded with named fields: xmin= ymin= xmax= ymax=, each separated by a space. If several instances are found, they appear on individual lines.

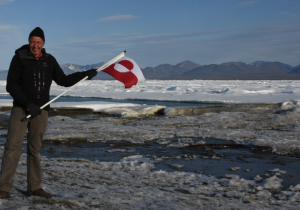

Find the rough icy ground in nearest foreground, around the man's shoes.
xmin=0 ymin=147 xmax=300 ymax=210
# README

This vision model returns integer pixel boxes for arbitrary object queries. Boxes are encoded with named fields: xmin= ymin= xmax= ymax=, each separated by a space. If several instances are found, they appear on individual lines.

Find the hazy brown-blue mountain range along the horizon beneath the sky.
xmin=0 ymin=61 xmax=300 ymax=80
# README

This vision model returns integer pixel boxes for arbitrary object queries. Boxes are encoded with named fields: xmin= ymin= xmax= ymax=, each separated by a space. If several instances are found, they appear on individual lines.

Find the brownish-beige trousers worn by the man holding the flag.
xmin=0 ymin=107 xmax=48 ymax=192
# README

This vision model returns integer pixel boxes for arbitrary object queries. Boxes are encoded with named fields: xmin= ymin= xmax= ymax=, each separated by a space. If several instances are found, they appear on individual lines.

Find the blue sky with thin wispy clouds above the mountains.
xmin=0 ymin=0 xmax=300 ymax=69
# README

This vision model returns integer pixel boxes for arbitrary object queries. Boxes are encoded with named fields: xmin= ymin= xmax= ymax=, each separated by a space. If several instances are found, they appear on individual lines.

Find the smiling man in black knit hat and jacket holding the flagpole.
xmin=0 ymin=27 xmax=97 ymax=198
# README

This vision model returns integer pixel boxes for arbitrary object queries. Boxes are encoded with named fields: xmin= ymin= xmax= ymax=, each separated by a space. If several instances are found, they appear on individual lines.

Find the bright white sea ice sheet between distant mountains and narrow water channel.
xmin=0 ymin=80 xmax=300 ymax=103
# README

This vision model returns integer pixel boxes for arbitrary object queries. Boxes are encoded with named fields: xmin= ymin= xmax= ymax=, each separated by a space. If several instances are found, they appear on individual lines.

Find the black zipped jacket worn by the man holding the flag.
xmin=6 ymin=45 xmax=86 ymax=110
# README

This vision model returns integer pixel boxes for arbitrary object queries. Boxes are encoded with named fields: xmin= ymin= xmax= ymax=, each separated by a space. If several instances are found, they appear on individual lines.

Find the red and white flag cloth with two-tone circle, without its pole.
xmin=102 ymin=56 xmax=145 ymax=88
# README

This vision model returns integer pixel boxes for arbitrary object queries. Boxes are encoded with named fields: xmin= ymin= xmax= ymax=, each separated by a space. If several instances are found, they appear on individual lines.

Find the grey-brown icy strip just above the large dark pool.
xmin=39 ymin=102 xmax=300 ymax=154
